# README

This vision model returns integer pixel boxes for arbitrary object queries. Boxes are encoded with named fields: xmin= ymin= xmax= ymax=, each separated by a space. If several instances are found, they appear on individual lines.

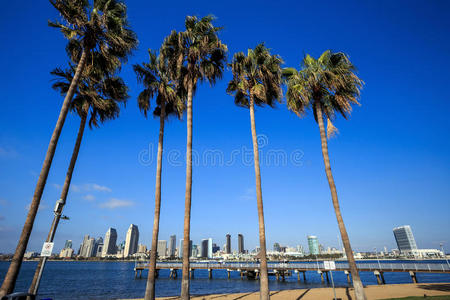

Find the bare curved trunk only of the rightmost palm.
xmin=315 ymin=104 xmax=367 ymax=300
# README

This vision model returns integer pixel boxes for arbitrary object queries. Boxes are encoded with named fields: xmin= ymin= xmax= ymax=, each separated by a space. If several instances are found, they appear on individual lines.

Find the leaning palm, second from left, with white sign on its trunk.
xmin=29 ymin=63 xmax=129 ymax=294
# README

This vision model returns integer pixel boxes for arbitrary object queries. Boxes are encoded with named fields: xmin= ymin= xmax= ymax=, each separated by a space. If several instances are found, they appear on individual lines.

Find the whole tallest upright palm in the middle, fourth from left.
xmin=161 ymin=16 xmax=227 ymax=300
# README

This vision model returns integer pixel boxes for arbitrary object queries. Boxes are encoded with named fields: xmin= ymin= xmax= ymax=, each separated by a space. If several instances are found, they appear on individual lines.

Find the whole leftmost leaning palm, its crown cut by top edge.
xmin=0 ymin=0 xmax=137 ymax=298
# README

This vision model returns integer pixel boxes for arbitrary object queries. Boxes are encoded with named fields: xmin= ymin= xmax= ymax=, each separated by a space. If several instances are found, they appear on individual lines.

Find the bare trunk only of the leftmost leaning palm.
xmin=0 ymin=51 xmax=86 ymax=298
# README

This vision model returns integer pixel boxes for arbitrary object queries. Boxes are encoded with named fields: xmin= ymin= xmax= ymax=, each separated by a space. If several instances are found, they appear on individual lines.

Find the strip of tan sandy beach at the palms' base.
xmin=144 ymin=283 xmax=450 ymax=300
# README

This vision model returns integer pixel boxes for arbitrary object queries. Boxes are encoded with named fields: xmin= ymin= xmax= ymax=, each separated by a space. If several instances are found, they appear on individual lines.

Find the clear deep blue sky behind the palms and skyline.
xmin=0 ymin=0 xmax=450 ymax=252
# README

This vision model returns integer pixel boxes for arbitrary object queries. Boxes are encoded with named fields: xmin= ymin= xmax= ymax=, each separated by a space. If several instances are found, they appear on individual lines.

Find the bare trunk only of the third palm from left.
xmin=145 ymin=99 xmax=166 ymax=300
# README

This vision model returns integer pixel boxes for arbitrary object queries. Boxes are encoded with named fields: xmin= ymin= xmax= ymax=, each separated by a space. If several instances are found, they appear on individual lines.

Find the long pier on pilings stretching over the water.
xmin=134 ymin=261 xmax=450 ymax=285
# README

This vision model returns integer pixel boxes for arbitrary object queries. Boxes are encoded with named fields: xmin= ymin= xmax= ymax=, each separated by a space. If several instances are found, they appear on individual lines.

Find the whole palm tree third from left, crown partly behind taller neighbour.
xmin=133 ymin=50 xmax=185 ymax=300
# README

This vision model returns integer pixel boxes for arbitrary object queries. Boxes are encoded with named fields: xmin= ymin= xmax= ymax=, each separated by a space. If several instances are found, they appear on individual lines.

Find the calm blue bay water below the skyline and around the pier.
xmin=0 ymin=261 xmax=450 ymax=299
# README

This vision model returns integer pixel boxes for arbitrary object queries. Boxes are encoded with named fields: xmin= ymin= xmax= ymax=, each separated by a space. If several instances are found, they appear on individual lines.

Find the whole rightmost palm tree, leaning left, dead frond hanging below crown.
xmin=283 ymin=50 xmax=366 ymax=300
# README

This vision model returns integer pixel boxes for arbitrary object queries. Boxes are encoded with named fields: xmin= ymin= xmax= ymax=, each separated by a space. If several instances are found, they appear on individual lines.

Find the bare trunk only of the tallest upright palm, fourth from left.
xmin=181 ymin=82 xmax=193 ymax=300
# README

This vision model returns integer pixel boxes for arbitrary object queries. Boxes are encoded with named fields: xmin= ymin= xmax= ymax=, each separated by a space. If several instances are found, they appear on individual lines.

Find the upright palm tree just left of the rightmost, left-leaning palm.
xmin=227 ymin=43 xmax=283 ymax=299
